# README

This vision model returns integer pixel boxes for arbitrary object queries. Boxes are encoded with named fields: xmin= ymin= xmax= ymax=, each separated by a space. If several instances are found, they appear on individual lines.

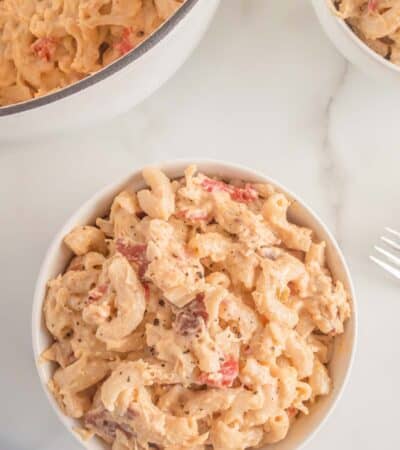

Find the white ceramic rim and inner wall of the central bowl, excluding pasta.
xmin=32 ymin=161 xmax=357 ymax=450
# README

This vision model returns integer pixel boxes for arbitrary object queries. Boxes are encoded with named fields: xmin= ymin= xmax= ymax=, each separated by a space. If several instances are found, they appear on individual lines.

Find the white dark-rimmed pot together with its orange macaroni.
xmin=0 ymin=0 xmax=219 ymax=139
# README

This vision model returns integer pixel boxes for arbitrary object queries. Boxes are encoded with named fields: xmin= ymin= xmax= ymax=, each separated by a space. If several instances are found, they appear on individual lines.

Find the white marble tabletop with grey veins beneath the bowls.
xmin=0 ymin=0 xmax=400 ymax=450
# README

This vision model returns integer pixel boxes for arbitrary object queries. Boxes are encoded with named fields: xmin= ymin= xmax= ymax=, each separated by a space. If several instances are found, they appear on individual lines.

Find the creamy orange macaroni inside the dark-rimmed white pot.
xmin=0 ymin=0 xmax=183 ymax=107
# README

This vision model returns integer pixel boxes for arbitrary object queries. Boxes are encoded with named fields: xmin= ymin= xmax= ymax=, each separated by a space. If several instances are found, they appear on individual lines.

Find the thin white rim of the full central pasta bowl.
xmin=31 ymin=158 xmax=358 ymax=450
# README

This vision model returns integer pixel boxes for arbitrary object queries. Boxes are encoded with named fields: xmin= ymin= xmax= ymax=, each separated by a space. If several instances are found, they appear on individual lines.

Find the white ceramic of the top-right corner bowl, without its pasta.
xmin=312 ymin=0 xmax=400 ymax=82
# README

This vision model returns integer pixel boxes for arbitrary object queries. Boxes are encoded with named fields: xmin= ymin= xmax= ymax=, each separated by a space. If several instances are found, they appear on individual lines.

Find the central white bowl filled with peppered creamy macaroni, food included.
xmin=33 ymin=161 xmax=356 ymax=450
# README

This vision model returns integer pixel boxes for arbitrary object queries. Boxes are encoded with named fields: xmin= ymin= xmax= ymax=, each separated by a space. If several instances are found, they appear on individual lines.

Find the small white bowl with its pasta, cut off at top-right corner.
xmin=312 ymin=0 xmax=400 ymax=83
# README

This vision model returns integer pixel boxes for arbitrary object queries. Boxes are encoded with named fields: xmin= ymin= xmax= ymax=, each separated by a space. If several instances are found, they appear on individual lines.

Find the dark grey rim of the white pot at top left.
xmin=0 ymin=0 xmax=200 ymax=120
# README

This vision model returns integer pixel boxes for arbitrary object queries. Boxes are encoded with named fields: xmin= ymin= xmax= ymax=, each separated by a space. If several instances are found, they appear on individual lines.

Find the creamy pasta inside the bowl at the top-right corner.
xmin=329 ymin=0 xmax=400 ymax=65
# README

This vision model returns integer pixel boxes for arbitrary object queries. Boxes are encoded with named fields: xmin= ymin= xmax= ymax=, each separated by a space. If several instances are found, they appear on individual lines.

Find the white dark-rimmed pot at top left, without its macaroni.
xmin=0 ymin=0 xmax=220 ymax=140
